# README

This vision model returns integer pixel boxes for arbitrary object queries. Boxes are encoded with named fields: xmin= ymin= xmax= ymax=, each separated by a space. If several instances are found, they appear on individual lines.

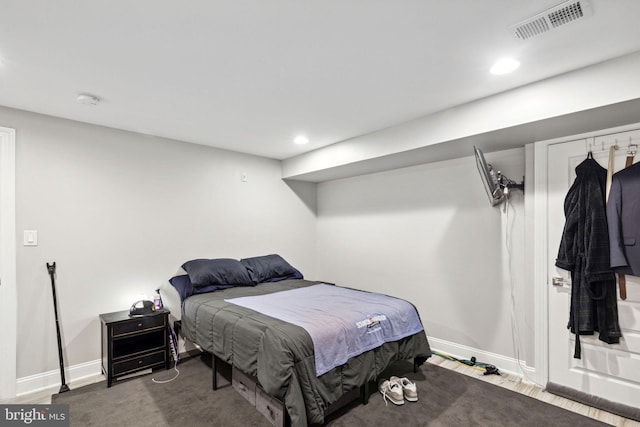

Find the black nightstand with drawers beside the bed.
xmin=100 ymin=309 xmax=171 ymax=387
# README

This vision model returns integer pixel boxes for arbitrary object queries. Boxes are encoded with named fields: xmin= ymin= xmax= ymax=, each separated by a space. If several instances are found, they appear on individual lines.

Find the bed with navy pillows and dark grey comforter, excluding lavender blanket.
xmin=160 ymin=255 xmax=431 ymax=427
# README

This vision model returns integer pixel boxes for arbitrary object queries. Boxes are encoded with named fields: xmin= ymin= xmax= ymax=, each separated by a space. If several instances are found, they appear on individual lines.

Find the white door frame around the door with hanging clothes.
xmin=533 ymin=123 xmax=640 ymax=386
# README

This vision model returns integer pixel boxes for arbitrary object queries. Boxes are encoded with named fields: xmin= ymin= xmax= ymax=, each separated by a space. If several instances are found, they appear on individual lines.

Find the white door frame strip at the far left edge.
xmin=0 ymin=127 xmax=18 ymax=399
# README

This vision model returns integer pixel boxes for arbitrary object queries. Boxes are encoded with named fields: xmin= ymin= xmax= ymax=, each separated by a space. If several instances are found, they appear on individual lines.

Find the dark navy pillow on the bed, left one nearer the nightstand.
xmin=182 ymin=258 xmax=254 ymax=288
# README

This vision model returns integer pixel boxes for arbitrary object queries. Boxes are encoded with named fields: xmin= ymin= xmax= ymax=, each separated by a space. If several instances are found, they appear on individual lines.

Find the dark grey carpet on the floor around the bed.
xmin=52 ymin=357 xmax=606 ymax=427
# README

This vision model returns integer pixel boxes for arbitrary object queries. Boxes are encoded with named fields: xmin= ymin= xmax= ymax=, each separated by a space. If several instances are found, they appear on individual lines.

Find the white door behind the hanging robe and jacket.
xmin=547 ymin=131 xmax=640 ymax=407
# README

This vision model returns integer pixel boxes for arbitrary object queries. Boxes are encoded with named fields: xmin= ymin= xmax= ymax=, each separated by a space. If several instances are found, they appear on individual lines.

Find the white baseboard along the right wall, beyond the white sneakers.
xmin=429 ymin=337 xmax=536 ymax=384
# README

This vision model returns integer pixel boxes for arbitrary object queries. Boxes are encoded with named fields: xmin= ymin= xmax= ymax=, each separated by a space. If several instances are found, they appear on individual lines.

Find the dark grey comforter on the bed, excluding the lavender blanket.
xmin=181 ymin=280 xmax=431 ymax=427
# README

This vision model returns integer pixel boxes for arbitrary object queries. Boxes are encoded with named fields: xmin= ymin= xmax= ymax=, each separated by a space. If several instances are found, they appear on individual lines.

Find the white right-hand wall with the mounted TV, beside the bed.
xmin=317 ymin=149 xmax=534 ymax=366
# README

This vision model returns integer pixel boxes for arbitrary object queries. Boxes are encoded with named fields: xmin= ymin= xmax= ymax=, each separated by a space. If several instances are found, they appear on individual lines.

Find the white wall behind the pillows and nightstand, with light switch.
xmin=0 ymin=107 xmax=316 ymax=379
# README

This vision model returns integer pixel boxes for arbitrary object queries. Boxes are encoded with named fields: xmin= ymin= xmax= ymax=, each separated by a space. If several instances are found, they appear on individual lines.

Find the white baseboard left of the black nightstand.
xmin=16 ymin=359 xmax=102 ymax=396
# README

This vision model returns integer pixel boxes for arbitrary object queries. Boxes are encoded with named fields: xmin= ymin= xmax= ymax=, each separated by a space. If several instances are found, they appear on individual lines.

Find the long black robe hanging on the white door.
xmin=556 ymin=153 xmax=622 ymax=359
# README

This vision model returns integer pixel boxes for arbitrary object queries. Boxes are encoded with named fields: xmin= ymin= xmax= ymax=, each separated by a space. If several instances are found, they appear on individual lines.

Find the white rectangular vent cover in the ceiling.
xmin=509 ymin=0 xmax=593 ymax=40
